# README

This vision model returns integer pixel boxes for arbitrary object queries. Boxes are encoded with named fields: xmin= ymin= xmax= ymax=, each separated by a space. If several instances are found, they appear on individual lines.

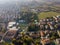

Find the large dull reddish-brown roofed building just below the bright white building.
xmin=3 ymin=30 xmax=17 ymax=42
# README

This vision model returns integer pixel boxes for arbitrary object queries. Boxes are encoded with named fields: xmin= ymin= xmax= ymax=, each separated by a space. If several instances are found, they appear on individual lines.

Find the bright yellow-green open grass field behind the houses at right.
xmin=38 ymin=12 xmax=60 ymax=19
